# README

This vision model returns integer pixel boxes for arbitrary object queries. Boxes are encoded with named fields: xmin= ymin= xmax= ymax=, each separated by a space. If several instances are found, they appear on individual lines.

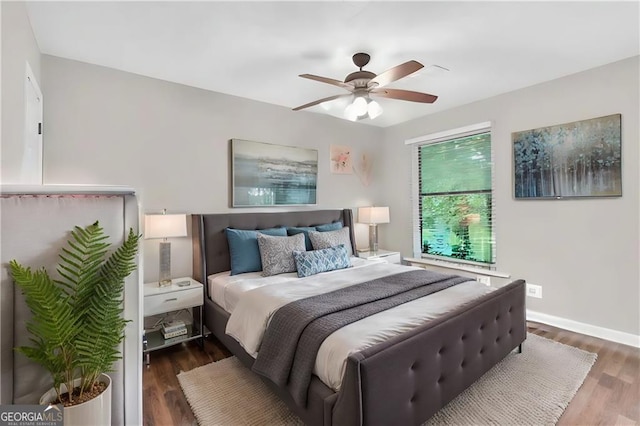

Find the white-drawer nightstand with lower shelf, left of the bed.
xmin=142 ymin=277 xmax=210 ymax=366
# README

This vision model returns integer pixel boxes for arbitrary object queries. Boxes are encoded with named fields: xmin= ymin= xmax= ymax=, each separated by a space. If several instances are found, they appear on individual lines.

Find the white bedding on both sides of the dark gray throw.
xmin=208 ymin=258 xmax=492 ymax=391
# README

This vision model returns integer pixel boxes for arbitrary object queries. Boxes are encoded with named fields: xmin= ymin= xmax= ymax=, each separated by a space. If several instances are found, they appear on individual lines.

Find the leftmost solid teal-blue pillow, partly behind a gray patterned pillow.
xmin=225 ymin=228 xmax=287 ymax=275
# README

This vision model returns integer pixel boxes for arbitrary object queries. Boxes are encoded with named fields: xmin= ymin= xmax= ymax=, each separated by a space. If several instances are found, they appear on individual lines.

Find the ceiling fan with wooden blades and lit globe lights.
xmin=293 ymin=53 xmax=438 ymax=121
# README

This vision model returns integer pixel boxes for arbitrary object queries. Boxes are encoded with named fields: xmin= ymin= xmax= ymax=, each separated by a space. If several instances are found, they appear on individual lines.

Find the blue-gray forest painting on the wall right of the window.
xmin=511 ymin=114 xmax=622 ymax=199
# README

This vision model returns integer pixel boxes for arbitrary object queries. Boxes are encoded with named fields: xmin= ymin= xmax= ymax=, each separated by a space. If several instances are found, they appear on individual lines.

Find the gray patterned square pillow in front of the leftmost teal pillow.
xmin=258 ymin=234 xmax=305 ymax=277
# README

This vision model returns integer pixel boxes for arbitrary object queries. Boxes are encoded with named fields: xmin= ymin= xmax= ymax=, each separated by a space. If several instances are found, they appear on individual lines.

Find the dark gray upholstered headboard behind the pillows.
xmin=191 ymin=209 xmax=356 ymax=287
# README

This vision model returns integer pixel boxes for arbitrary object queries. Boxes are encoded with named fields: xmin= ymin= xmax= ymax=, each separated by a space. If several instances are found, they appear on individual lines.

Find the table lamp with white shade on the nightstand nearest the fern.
xmin=144 ymin=209 xmax=187 ymax=287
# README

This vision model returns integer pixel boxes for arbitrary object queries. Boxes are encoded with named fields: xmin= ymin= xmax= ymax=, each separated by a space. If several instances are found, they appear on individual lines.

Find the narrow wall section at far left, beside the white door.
xmin=0 ymin=1 xmax=42 ymax=184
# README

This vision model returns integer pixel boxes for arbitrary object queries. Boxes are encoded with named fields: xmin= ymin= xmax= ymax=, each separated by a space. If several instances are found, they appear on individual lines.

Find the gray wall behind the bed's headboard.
xmin=42 ymin=55 xmax=382 ymax=281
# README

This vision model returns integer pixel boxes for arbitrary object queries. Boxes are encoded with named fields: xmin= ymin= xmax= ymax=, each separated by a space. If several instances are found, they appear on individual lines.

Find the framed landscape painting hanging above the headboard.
xmin=231 ymin=139 xmax=318 ymax=207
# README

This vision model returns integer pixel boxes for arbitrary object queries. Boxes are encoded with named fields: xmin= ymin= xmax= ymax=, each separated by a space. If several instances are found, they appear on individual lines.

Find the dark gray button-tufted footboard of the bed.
xmin=324 ymin=280 xmax=526 ymax=426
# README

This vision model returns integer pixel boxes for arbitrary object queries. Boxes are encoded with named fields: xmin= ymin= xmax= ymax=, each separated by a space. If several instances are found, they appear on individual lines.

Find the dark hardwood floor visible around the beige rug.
xmin=142 ymin=322 xmax=640 ymax=426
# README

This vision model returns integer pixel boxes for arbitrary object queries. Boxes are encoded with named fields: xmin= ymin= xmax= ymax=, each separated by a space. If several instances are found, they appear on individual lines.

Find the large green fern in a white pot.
xmin=9 ymin=222 xmax=140 ymax=425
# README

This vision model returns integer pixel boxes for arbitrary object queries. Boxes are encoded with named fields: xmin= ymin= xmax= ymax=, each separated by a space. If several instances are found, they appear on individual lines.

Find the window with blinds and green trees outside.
xmin=408 ymin=123 xmax=495 ymax=265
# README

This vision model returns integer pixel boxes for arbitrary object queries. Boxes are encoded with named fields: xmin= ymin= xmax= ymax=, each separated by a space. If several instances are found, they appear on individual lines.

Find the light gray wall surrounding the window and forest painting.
xmin=381 ymin=57 xmax=640 ymax=335
